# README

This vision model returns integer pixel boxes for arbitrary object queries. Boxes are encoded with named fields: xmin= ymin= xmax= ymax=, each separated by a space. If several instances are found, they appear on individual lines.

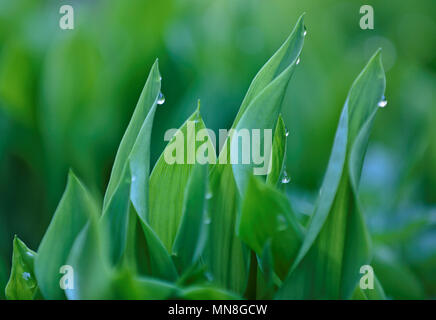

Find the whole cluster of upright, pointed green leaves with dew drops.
xmin=6 ymin=17 xmax=385 ymax=299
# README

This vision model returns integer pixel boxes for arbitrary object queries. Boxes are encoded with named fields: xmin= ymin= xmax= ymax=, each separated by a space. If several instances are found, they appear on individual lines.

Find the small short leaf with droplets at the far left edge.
xmin=5 ymin=236 xmax=38 ymax=300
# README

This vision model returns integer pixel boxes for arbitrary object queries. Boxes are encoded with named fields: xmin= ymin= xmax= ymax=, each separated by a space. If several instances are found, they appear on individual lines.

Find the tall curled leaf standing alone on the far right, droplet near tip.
xmin=277 ymin=52 xmax=385 ymax=299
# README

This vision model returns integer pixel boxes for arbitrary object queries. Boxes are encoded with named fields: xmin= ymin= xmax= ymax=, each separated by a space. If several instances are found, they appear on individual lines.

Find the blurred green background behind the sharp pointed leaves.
xmin=0 ymin=0 xmax=436 ymax=298
